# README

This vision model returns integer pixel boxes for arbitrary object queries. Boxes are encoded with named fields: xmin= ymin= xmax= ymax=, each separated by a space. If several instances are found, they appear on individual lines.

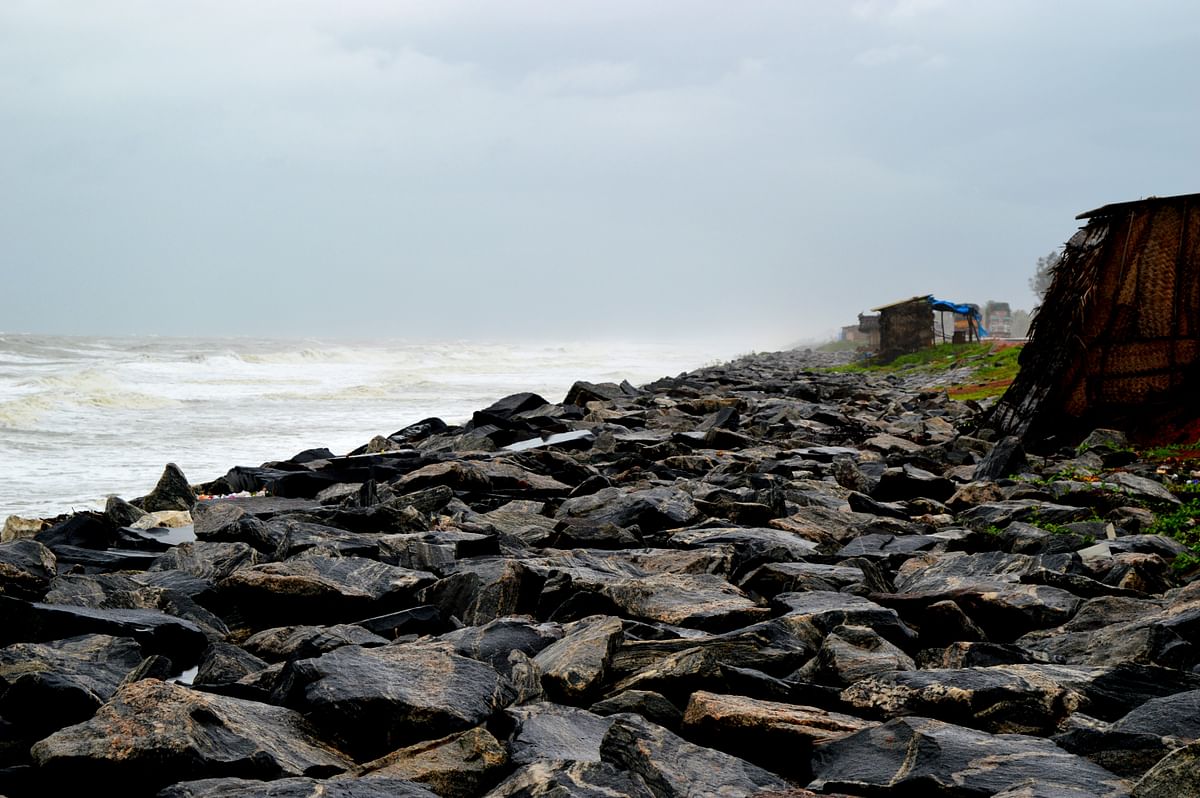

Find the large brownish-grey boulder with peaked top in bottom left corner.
xmin=31 ymin=679 xmax=350 ymax=792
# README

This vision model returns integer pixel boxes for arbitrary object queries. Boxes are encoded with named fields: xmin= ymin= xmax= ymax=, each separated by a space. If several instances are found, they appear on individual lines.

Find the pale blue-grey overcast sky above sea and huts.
xmin=0 ymin=0 xmax=1200 ymax=348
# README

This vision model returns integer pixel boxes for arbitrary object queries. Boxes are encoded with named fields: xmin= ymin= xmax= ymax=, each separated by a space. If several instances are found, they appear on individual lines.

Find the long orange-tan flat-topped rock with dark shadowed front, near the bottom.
xmin=683 ymin=691 xmax=878 ymax=781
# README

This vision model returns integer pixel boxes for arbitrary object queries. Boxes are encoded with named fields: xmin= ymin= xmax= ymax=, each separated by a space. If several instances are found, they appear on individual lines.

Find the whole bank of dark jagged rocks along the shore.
xmin=0 ymin=352 xmax=1200 ymax=798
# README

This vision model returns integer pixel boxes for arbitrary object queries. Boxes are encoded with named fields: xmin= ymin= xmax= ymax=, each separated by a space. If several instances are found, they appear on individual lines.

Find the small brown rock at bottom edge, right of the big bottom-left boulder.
xmin=362 ymin=728 xmax=509 ymax=798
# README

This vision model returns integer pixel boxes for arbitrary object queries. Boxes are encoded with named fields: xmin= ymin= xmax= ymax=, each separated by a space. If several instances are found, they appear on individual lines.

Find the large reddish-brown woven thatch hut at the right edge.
xmin=991 ymin=194 xmax=1200 ymax=443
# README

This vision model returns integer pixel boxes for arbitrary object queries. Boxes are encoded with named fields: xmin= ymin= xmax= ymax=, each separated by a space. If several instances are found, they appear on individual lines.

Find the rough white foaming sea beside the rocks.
xmin=0 ymin=334 xmax=739 ymax=520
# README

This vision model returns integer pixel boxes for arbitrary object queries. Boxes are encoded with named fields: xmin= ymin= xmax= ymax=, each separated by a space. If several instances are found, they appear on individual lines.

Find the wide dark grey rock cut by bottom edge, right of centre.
xmin=809 ymin=718 xmax=1129 ymax=798
